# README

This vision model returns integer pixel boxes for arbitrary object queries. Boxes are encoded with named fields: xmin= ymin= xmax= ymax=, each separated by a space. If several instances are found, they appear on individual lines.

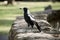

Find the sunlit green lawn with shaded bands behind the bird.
xmin=0 ymin=2 xmax=60 ymax=34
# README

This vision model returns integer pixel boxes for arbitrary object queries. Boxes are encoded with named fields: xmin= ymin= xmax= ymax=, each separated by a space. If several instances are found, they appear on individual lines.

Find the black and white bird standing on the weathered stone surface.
xmin=20 ymin=7 xmax=41 ymax=32
